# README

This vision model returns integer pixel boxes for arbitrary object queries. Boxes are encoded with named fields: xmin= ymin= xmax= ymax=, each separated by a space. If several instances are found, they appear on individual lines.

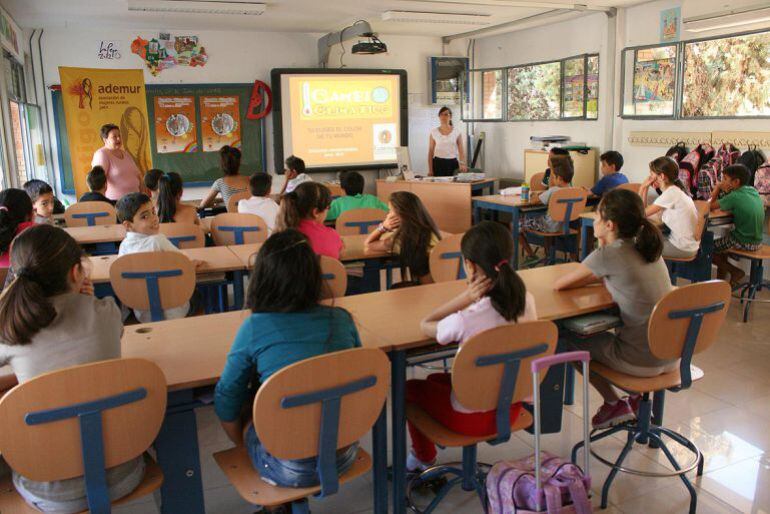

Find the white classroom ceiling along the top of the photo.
xmin=0 ymin=0 xmax=643 ymax=36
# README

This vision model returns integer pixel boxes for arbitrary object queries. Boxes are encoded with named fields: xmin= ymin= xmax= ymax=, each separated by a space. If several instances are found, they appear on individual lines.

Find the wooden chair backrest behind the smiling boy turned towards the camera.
xmin=110 ymin=252 xmax=195 ymax=321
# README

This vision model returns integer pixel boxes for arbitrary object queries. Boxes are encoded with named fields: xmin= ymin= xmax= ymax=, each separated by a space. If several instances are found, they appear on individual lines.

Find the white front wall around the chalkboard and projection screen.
xmin=33 ymin=28 xmax=442 ymax=196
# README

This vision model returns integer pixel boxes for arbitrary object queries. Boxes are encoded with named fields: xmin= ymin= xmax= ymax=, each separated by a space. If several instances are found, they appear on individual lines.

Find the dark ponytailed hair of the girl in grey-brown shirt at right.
xmin=598 ymin=189 xmax=663 ymax=262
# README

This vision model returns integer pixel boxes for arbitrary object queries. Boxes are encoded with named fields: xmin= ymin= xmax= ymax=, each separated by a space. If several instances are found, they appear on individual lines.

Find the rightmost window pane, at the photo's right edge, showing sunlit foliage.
xmin=682 ymin=32 xmax=770 ymax=118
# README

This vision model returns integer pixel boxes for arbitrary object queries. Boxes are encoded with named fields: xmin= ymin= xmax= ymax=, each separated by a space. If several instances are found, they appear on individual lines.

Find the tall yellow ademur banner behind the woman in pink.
xmin=59 ymin=66 xmax=152 ymax=196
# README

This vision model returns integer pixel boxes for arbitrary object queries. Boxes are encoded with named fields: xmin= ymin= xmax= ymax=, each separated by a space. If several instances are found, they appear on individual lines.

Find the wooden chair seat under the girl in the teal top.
xmin=212 ymin=446 xmax=372 ymax=504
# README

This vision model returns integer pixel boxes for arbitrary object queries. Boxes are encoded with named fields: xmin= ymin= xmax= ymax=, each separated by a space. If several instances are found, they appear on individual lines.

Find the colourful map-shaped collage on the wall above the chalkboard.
xmin=131 ymin=32 xmax=209 ymax=76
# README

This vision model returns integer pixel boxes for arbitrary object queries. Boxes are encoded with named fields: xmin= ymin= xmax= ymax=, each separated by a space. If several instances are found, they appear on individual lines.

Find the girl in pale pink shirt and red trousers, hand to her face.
xmin=406 ymin=221 xmax=537 ymax=472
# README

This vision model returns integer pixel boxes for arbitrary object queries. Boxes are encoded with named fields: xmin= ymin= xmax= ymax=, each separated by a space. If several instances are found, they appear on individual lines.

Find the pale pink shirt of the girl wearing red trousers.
xmin=436 ymin=292 xmax=537 ymax=413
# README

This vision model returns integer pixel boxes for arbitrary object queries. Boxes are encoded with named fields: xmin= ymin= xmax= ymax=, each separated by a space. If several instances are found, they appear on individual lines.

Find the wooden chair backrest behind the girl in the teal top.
xmin=253 ymin=348 xmax=390 ymax=496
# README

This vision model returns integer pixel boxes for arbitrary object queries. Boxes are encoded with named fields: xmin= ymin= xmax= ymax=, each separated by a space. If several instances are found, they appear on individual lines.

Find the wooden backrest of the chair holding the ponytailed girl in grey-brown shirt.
xmin=647 ymin=280 xmax=731 ymax=389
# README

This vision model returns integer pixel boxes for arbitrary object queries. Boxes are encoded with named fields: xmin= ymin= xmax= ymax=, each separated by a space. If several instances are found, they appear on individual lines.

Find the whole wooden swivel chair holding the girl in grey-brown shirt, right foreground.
xmin=572 ymin=280 xmax=730 ymax=514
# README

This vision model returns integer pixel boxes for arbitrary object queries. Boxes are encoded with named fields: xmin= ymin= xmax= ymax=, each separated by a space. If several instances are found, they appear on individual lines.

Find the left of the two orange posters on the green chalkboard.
xmin=155 ymin=96 xmax=198 ymax=153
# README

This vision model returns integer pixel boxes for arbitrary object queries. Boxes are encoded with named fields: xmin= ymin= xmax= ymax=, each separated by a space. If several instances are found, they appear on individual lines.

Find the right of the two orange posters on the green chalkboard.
xmin=200 ymin=96 xmax=241 ymax=152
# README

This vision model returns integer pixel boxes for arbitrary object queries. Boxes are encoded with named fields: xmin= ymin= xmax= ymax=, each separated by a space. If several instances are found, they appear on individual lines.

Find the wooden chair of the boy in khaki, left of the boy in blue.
xmin=525 ymin=187 xmax=588 ymax=264
